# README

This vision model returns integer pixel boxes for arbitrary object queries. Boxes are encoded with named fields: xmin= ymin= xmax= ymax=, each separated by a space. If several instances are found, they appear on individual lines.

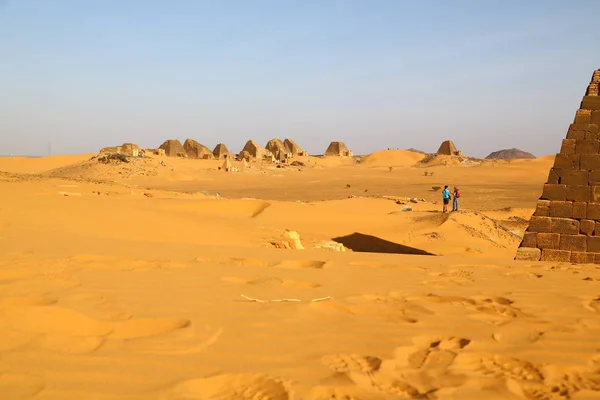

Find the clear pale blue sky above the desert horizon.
xmin=0 ymin=0 xmax=600 ymax=156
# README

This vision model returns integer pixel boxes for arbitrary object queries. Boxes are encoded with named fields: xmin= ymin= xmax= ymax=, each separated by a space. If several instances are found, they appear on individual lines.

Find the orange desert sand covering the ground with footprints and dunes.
xmin=0 ymin=150 xmax=600 ymax=400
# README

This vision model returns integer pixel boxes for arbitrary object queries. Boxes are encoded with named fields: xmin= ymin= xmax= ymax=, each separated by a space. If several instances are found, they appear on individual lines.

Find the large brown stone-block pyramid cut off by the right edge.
xmin=515 ymin=69 xmax=600 ymax=264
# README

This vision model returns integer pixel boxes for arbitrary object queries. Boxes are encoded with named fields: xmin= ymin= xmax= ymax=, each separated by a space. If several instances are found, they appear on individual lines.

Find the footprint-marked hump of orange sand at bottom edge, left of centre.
xmin=167 ymin=374 xmax=293 ymax=400
